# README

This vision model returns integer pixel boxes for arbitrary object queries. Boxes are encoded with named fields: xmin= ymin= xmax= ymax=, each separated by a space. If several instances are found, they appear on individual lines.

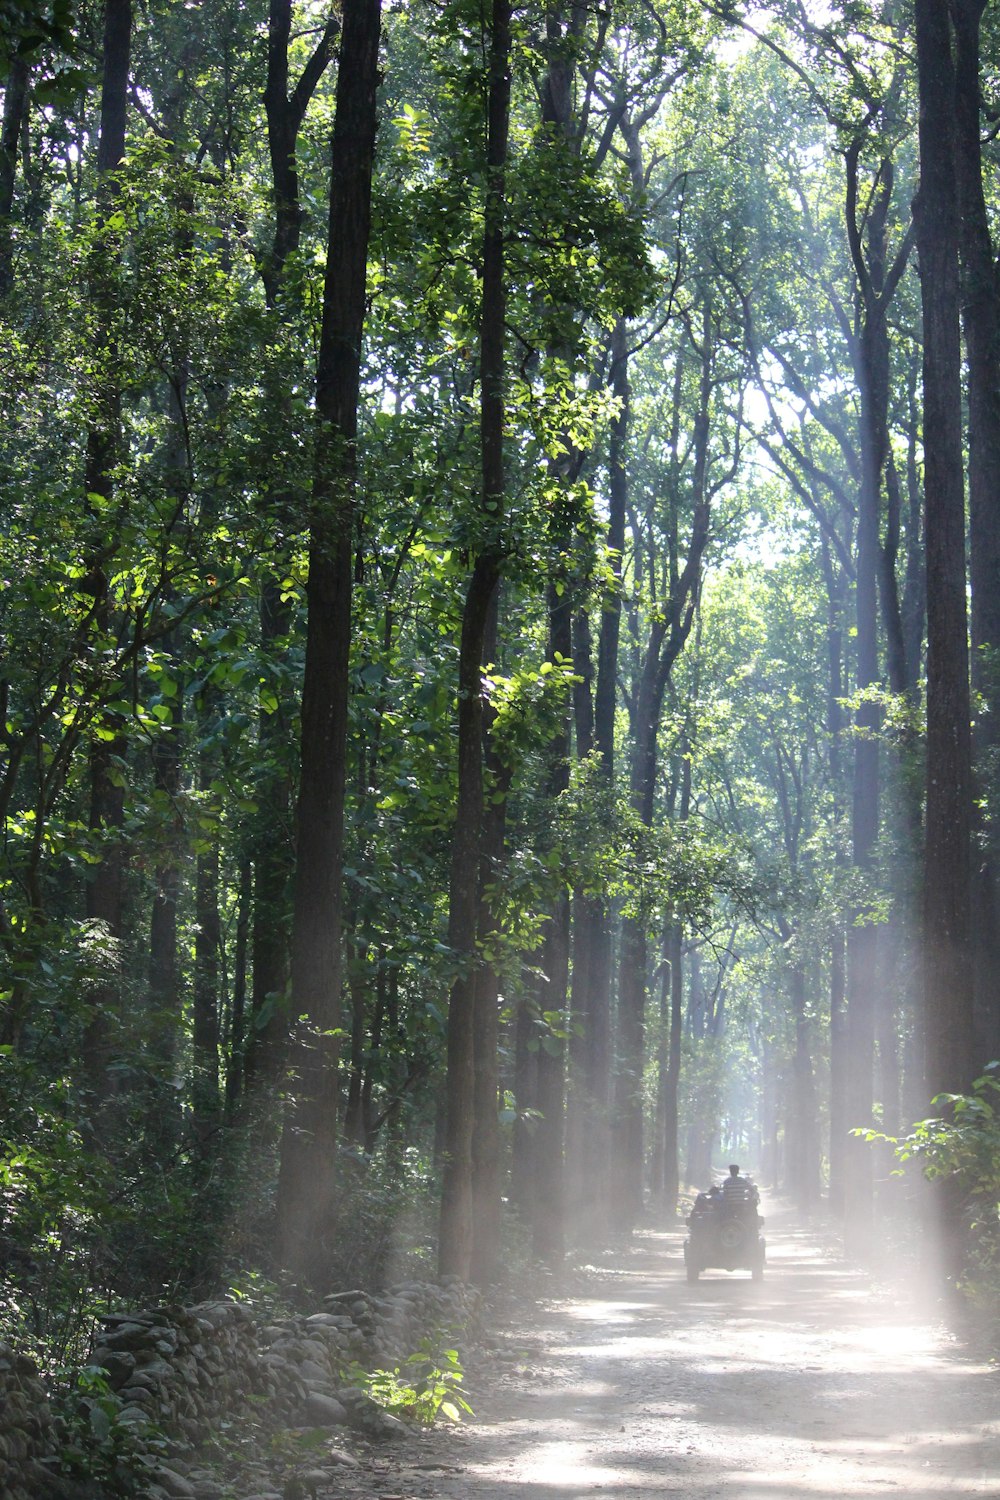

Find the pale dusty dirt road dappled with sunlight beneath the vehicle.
xmin=364 ymin=1221 xmax=1000 ymax=1500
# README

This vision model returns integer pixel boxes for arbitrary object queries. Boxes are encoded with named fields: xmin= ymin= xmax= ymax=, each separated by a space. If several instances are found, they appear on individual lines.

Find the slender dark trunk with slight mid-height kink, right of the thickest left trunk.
xmin=438 ymin=0 xmax=511 ymax=1280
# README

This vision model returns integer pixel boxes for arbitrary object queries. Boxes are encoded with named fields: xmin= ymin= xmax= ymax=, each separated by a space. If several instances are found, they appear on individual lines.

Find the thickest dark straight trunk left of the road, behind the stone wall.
xmin=277 ymin=0 xmax=381 ymax=1289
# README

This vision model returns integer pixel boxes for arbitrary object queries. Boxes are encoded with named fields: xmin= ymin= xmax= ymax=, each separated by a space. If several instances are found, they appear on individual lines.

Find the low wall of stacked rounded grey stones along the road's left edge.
xmin=0 ymin=1281 xmax=478 ymax=1500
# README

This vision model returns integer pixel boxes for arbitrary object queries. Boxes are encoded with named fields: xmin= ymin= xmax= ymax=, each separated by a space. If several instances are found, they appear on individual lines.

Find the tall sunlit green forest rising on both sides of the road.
xmin=0 ymin=0 xmax=1000 ymax=1368
